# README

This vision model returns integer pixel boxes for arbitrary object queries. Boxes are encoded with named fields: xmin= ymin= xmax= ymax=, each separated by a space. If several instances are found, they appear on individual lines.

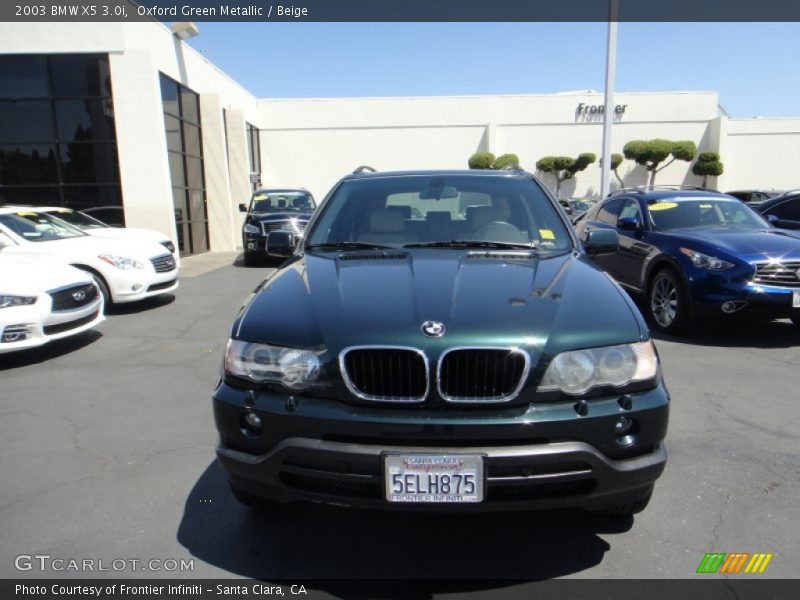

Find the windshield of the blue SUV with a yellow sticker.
xmin=648 ymin=197 xmax=770 ymax=231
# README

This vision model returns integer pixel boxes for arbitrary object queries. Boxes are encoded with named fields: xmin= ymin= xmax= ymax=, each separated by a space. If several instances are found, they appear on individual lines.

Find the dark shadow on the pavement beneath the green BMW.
xmin=177 ymin=461 xmax=633 ymax=584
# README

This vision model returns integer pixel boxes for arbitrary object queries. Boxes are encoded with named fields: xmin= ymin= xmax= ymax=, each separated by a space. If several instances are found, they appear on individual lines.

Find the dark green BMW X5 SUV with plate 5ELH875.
xmin=213 ymin=169 xmax=669 ymax=514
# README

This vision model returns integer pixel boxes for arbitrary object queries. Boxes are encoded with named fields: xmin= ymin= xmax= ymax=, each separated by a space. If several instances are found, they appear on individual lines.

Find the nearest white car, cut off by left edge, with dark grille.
xmin=0 ymin=255 xmax=105 ymax=354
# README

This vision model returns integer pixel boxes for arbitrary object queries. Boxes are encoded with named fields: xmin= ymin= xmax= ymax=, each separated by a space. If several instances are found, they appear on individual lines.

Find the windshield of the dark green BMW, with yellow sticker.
xmin=307 ymin=175 xmax=573 ymax=250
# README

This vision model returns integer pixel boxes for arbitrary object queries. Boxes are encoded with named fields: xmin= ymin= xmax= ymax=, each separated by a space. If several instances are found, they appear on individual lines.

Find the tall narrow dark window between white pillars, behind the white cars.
xmin=161 ymin=73 xmax=209 ymax=256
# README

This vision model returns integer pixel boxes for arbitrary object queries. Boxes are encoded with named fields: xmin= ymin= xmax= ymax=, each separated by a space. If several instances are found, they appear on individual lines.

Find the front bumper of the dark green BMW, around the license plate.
xmin=214 ymin=384 xmax=669 ymax=511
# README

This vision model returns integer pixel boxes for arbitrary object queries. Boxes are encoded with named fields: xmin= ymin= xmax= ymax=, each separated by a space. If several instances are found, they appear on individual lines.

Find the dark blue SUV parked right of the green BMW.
xmin=576 ymin=188 xmax=800 ymax=333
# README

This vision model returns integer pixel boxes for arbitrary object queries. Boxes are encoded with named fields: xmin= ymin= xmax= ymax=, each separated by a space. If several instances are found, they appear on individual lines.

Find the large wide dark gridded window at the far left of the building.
xmin=0 ymin=54 xmax=124 ymax=220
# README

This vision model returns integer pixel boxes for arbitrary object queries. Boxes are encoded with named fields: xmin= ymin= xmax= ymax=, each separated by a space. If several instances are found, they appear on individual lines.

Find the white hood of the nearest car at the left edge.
xmin=0 ymin=256 xmax=92 ymax=296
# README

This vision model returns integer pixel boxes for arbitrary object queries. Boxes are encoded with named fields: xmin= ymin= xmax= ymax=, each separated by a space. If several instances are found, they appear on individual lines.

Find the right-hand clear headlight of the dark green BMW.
xmin=539 ymin=340 xmax=658 ymax=394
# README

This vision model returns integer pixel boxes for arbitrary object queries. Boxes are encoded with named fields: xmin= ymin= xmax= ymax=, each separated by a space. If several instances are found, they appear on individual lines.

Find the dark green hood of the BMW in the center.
xmin=233 ymin=249 xmax=648 ymax=356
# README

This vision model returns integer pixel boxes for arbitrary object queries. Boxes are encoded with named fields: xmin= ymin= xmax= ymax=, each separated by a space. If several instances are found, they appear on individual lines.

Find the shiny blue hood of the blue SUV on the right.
xmin=671 ymin=227 xmax=800 ymax=260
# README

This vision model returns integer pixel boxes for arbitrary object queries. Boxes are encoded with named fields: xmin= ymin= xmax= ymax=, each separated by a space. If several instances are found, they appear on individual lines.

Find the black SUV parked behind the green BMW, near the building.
xmin=239 ymin=189 xmax=317 ymax=266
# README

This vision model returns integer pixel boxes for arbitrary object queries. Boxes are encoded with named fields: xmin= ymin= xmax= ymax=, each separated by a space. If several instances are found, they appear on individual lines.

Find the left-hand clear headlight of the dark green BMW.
xmin=225 ymin=340 xmax=322 ymax=390
